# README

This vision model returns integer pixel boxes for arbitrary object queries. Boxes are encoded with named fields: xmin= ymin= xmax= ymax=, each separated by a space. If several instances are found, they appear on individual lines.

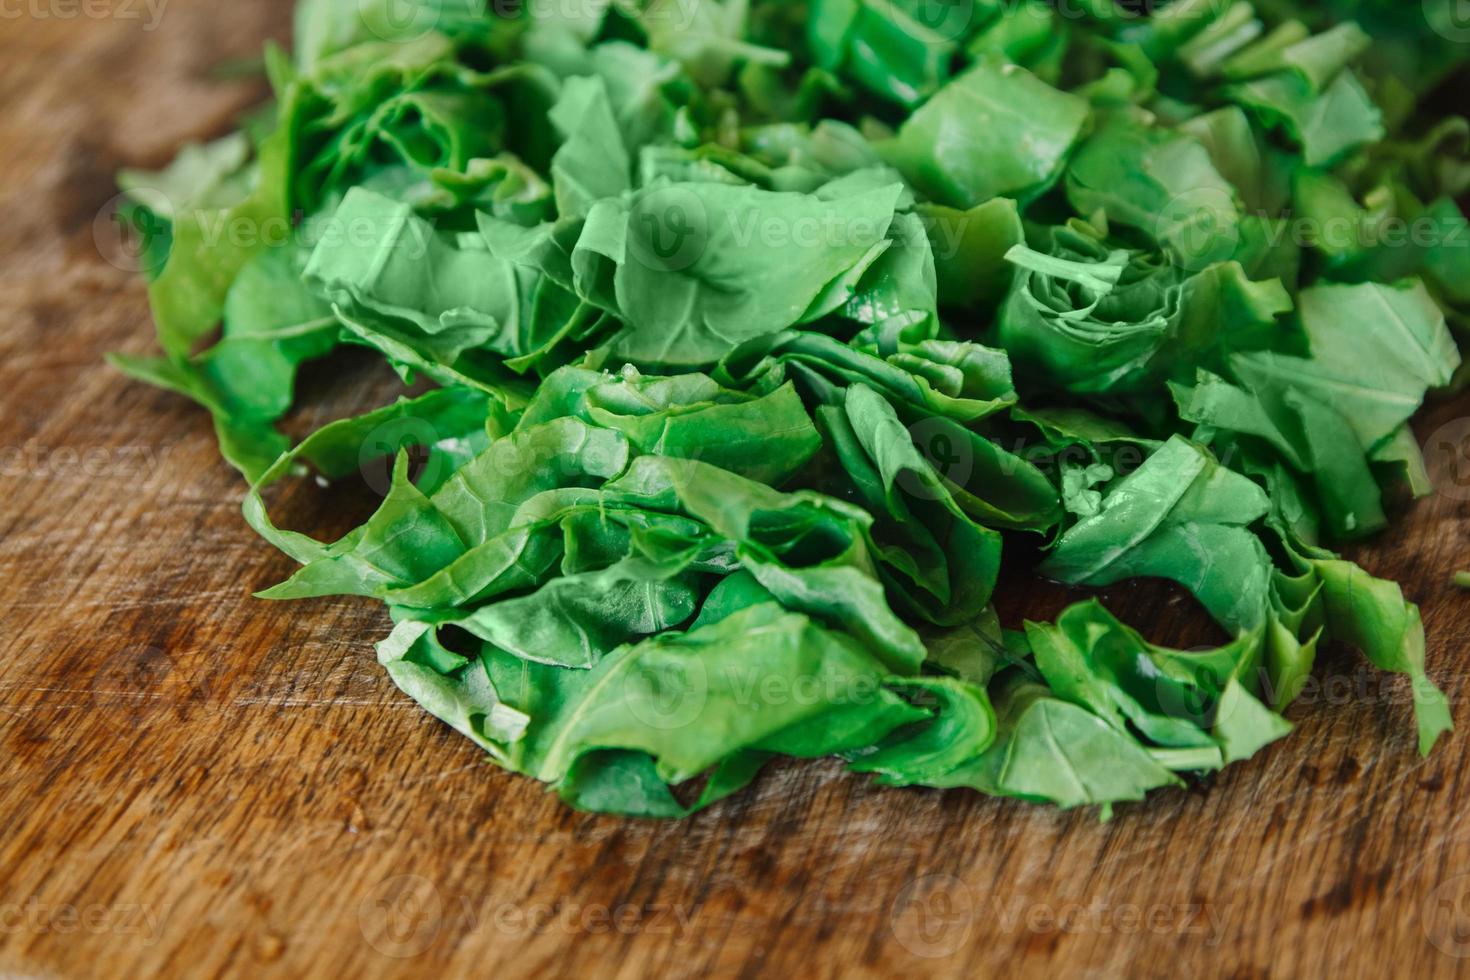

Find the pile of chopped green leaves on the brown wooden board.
xmin=113 ymin=0 xmax=1470 ymax=817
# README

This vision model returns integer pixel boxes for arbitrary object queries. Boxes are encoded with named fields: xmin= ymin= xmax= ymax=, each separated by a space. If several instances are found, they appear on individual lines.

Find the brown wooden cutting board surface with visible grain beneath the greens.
xmin=0 ymin=0 xmax=1470 ymax=979
